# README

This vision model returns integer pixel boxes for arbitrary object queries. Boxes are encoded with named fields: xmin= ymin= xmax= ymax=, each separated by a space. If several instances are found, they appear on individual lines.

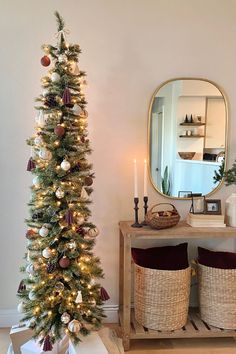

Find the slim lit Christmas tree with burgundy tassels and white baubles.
xmin=18 ymin=12 xmax=108 ymax=351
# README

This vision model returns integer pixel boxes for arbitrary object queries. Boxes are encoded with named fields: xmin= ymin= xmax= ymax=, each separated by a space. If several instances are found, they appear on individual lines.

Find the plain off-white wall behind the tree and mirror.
xmin=0 ymin=0 xmax=236 ymax=320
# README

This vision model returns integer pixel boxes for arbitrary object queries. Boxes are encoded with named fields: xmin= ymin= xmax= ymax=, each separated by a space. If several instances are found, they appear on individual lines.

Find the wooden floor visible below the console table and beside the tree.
xmin=0 ymin=325 xmax=236 ymax=354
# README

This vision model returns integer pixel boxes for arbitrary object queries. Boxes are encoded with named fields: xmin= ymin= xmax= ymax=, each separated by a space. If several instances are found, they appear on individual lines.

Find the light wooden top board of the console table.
xmin=119 ymin=221 xmax=236 ymax=239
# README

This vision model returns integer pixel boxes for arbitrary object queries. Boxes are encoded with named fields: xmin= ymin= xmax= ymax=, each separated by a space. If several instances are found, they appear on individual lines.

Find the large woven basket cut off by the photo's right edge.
xmin=197 ymin=263 xmax=236 ymax=329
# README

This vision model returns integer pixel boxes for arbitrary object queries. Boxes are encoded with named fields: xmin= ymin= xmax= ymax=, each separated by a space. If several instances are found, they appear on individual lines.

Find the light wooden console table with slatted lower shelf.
xmin=119 ymin=221 xmax=236 ymax=350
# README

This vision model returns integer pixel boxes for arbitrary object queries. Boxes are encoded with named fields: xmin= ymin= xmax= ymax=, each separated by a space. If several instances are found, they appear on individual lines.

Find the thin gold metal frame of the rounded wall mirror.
xmin=147 ymin=77 xmax=228 ymax=200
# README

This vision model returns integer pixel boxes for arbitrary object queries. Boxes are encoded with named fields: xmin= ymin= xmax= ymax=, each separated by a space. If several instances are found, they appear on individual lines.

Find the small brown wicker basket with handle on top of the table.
xmin=145 ymin=203 xmax=180 ymax=229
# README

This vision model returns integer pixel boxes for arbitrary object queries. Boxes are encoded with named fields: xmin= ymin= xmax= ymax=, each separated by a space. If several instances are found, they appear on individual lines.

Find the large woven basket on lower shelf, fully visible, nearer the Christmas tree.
xmin=134 ymin=264 xmax=191 ymax=331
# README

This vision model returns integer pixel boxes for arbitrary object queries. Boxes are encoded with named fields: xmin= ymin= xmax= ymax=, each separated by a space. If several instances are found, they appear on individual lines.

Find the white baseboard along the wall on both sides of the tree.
xmin=0 ymin=305 xmax=118 ymax=328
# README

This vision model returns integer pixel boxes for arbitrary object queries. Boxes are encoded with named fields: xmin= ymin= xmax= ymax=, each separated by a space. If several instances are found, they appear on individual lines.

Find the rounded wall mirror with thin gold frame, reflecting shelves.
xmin=148 ymin=78 xmax=227 ymax=198
